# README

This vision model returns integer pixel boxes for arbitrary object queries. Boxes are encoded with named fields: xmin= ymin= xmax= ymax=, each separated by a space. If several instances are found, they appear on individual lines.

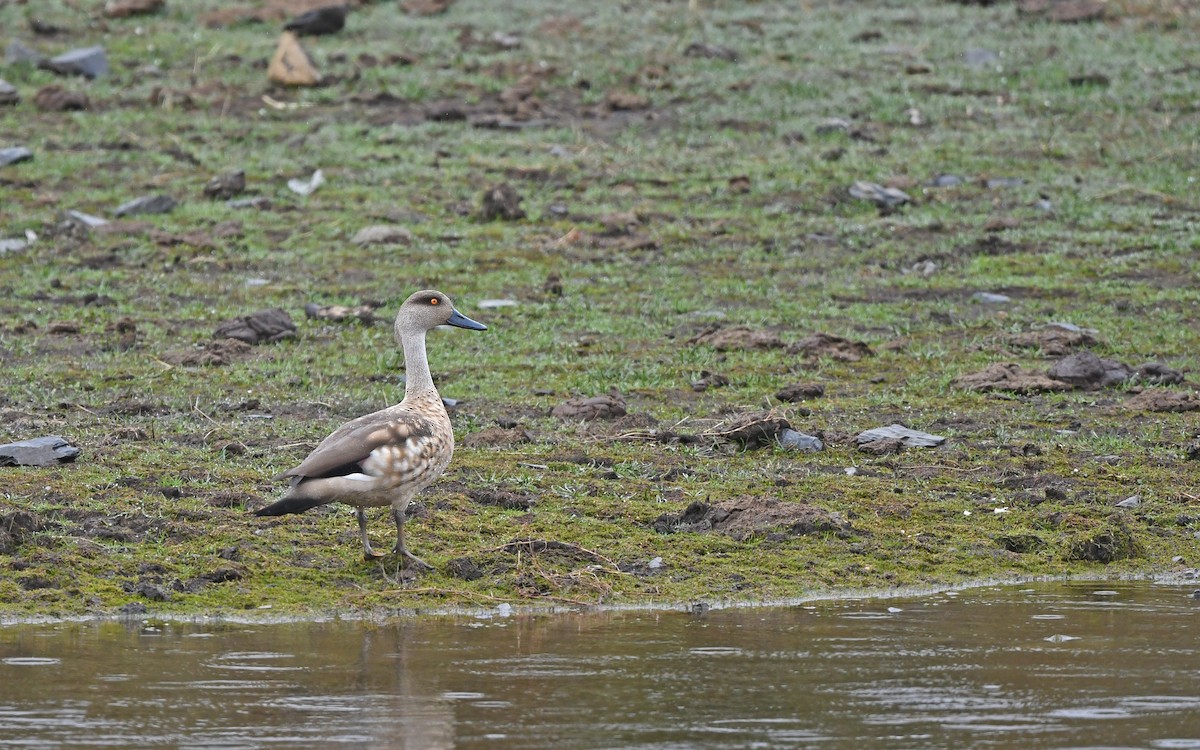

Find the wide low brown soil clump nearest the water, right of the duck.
xmin=653 ymin=496 xmax=856 ymax=541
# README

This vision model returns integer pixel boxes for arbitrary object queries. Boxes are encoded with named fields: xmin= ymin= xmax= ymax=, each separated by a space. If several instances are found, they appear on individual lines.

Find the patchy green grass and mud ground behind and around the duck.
xmin=0 ymin=0 xmax=1200 ymax=616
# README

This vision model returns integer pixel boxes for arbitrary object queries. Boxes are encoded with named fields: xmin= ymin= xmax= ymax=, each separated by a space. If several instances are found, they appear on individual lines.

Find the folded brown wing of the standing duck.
xmin=275 ymin=408 xmax=436 ymax=479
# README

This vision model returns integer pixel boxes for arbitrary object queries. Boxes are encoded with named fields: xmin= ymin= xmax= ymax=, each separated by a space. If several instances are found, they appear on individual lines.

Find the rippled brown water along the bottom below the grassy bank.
xmin=0 ymin=583 xmax=1200 ymax=750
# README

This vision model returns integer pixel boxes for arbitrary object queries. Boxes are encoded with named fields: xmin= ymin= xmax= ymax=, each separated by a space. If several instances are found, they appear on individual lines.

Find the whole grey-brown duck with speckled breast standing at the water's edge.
xmin=254 ymin=289 xmax=487 ymax=568
